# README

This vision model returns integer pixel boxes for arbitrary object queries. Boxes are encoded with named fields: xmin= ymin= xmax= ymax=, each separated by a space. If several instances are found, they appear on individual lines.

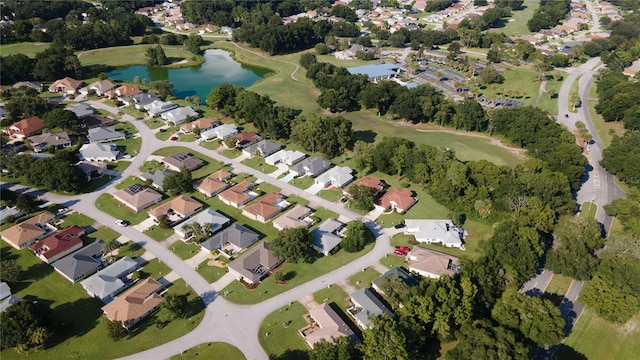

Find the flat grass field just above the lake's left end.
xmin=77 ymin=45 xmax=197 ymax=67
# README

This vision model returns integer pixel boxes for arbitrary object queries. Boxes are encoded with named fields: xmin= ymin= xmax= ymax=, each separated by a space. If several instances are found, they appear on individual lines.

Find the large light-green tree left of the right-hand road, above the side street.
xmin=546 ymin=216 xmax=604 ymax=280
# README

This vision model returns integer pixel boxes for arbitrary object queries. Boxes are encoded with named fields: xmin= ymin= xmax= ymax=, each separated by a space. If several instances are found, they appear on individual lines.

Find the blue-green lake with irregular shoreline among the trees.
xmin=108 ymin=49 xmax=271 ymax=104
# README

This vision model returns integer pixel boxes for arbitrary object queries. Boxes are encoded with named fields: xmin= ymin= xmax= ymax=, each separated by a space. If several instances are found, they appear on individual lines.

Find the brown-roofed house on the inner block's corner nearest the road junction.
xmin=228 ymin=241 xmax=284 ymax=285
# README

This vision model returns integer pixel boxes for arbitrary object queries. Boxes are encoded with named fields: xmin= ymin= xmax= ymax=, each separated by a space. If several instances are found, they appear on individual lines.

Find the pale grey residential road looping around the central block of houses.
xmin=31 ymin=101 xmax=390 ymax=360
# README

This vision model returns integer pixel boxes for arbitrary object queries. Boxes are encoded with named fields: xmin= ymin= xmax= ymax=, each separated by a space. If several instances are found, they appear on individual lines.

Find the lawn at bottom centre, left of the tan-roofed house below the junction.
xmin=258 ymin=301 xmax=308 ymax=360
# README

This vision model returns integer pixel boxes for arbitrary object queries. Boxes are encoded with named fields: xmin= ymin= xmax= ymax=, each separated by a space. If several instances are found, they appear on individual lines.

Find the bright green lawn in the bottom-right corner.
xmin=554 ymin=308 xmax=640 ymax=360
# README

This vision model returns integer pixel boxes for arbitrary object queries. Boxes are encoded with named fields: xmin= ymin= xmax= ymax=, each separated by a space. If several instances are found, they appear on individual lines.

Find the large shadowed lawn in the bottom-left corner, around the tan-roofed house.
xmin=0 ymin=244 xmax=204 ymax=360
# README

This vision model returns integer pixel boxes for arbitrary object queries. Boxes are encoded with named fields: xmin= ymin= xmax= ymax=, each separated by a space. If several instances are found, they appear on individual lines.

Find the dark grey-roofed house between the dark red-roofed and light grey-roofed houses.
xmin=51 ymin=240 xmax=104 ymax=284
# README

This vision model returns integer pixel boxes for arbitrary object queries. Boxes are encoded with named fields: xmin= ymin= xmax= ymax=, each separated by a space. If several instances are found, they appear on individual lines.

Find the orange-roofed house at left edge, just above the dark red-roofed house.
xmin=0 ymin=211 xmax=57 ymax=250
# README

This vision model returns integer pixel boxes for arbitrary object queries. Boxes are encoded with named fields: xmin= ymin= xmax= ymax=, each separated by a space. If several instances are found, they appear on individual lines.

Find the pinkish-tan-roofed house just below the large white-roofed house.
xmin=407 ymin=246 xmax=460 ymax=279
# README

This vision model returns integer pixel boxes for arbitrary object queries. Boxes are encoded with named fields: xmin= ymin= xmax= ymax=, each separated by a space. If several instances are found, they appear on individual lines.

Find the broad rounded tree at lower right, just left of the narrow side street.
xmin=491 ymin=290 xmax=565 ymax=347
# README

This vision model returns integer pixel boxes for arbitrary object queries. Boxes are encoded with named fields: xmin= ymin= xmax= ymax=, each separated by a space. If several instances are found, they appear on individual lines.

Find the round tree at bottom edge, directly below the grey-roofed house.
xmin=357 ymin=315 xmax=409 ymax=360
